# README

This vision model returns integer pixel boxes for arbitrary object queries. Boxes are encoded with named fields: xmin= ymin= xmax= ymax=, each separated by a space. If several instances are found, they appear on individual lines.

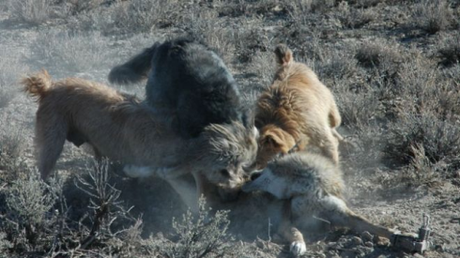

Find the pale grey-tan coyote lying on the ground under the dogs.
xmin=242 ymin=152 xmax=397 ymax=255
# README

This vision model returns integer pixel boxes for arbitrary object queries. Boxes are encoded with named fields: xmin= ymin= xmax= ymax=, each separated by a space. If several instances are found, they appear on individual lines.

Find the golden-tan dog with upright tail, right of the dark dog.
xmin=256 ymin=45 xmax=343 ymax=168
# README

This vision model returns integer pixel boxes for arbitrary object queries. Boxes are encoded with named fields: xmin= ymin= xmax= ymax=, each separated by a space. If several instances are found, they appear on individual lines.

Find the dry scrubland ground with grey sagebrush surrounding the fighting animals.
xmin=0 ymin=0 xmax=460 ymax=257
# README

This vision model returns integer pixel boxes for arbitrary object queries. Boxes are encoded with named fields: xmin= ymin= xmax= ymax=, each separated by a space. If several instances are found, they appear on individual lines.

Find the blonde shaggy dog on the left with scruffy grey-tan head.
xmin=22 ymin=71 xmax=257 ymax=208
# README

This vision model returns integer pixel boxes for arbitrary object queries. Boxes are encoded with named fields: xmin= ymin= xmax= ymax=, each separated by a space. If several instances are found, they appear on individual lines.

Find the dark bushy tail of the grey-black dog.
xmin=109 ymin=42 xmax=160 ymax=84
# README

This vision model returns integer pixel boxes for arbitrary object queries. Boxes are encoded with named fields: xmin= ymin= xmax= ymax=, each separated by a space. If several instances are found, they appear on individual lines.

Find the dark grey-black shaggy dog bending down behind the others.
xmin=109 ymin=38 xmax=248 ymax=138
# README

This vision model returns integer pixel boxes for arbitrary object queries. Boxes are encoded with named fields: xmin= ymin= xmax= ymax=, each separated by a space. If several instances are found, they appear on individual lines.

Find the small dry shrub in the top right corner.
xmin=413 ymin=0 xmax=456 ymax=34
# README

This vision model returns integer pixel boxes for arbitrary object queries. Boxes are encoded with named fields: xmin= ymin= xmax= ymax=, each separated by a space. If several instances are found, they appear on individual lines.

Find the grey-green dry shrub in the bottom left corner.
xmin=1 ymin=171 xmax=58 ymax=255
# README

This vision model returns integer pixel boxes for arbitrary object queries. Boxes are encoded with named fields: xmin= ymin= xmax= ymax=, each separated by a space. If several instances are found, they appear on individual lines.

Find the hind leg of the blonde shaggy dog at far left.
xmin=35 ymin=111 xmax=68 ymax=180
